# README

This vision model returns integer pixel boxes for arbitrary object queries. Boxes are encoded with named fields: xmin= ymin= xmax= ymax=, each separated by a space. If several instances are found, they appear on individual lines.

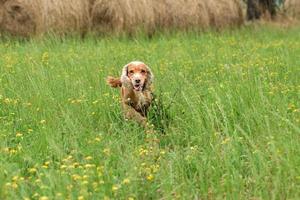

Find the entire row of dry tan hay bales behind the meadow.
xmin=0 ymin=0 xmax=300 ymax=37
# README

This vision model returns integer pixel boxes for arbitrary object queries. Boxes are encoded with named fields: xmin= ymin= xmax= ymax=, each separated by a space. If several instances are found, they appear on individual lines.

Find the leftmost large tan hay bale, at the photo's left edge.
xmin=0 ymin=0 xmax=90 ymax=37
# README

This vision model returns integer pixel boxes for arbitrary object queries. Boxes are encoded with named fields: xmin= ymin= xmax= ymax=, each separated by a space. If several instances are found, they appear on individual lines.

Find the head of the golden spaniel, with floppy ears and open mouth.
xmin=121 ymin=61 xmax=153 ymax=91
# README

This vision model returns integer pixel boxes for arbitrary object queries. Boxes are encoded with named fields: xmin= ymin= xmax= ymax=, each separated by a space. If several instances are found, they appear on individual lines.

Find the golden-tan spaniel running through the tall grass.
xmin=107 ymin=61 xmax=153 ymax=126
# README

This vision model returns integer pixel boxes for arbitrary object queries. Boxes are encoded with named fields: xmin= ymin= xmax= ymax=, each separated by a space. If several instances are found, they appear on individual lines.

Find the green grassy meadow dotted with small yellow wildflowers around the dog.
xmin=0 ymin=27 xmax=300 ymax=200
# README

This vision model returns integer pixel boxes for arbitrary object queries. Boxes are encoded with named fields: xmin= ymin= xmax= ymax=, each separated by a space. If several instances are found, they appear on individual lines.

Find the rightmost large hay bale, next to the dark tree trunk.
xmin=153 ymin=0 xmax=244 ymax=30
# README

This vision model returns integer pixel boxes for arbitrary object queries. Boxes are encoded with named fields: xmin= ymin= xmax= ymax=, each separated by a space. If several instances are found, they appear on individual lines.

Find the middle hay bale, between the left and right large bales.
xmin=91 ymin=0 xmax=154 ymax=34
